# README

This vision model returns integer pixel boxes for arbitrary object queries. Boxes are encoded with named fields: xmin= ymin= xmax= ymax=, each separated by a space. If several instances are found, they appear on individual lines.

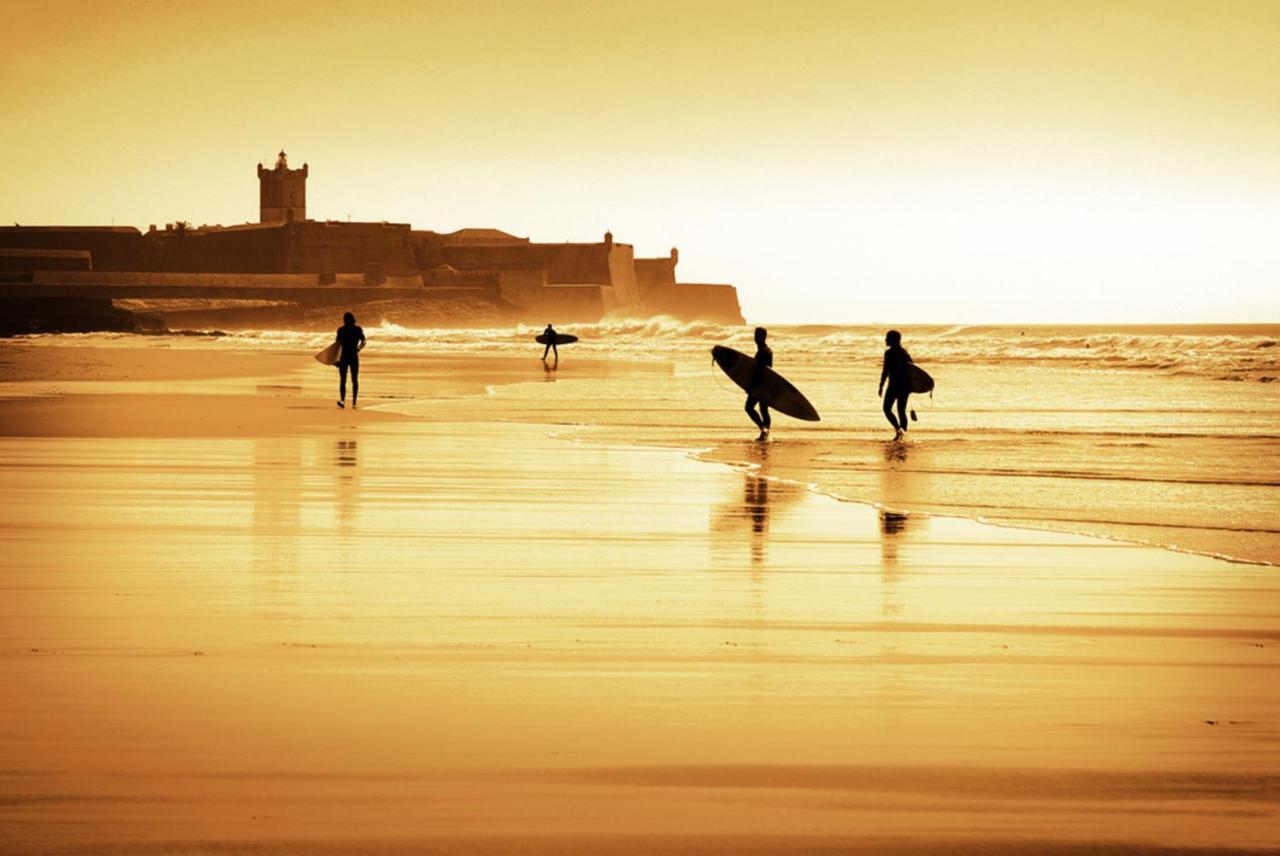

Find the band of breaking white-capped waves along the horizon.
xmin=17 ymin=323 xmax=1280 ymax=384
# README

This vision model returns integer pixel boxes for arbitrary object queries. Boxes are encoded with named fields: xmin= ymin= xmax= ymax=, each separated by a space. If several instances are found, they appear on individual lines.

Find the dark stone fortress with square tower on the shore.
xmin=0 ymin=151 xmax=742 ymax=328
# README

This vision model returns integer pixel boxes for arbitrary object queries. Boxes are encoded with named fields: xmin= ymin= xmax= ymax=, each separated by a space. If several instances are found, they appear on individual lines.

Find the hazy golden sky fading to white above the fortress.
xmin=0 ymin=0 xmax=1280 ymax=324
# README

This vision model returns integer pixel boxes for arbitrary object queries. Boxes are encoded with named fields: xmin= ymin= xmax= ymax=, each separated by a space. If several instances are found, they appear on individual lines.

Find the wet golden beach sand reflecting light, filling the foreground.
xmin=0 ymin=344 xmax=1280 ymax=853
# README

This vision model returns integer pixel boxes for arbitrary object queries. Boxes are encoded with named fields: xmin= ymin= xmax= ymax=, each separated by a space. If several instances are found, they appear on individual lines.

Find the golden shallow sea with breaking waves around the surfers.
xmin=27 ymin=317 xmax=1280 ymax=564
